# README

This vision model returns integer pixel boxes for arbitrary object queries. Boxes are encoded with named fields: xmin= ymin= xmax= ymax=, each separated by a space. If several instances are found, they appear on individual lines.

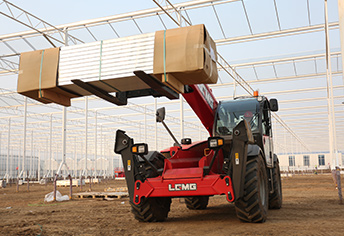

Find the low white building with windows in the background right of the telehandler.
xmin=277 ymin=153 xmax=344 ymax=170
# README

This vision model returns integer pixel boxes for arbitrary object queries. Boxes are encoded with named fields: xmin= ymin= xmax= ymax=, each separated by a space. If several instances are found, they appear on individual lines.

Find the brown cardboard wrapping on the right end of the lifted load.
xmin=153 ymin=25 xmax=218 ymax=84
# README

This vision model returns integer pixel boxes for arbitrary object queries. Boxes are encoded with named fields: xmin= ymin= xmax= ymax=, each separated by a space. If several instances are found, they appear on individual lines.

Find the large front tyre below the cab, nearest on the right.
xmin=235 ymin=155 xmax=269 ymax=223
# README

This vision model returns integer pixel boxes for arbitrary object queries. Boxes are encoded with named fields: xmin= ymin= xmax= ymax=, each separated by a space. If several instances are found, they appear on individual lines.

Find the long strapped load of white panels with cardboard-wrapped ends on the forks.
xmin=18 ymin=25 xmax=218 ymax=106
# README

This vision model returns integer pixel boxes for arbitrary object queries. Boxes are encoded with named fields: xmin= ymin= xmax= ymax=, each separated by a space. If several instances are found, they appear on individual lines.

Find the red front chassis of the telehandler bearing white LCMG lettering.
xmin=133 ymin=142 xmax=234 ymax=204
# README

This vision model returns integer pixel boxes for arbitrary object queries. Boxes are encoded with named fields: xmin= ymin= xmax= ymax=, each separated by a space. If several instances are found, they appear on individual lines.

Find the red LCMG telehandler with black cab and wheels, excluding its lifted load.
xmin=115 ymin=77 xmax=282 ymax=222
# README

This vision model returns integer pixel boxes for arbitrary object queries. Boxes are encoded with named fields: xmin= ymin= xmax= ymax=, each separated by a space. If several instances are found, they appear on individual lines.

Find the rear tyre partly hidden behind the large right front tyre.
xmin=269 ymin=160 xmax=282 ymax=209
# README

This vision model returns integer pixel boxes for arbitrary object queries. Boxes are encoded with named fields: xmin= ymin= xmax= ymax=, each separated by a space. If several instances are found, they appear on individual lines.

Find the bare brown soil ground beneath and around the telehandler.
xmin=0 ymin=175 xmax=344 ymax=236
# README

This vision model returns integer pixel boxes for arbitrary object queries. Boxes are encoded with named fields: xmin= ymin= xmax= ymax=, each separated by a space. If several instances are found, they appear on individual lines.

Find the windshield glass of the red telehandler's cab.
xmin=215 ymin=99 xmax=259 ymax=135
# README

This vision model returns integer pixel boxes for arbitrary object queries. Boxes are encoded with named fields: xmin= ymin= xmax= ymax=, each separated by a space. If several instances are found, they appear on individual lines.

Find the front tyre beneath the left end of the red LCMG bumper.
xmin=130 ymin=197 xmax=171 ymax=222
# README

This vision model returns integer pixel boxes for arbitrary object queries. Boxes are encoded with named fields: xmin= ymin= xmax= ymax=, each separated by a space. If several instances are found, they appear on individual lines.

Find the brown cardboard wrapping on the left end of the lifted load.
xmin=17 ymin=48 xmax=77 ymax=106
